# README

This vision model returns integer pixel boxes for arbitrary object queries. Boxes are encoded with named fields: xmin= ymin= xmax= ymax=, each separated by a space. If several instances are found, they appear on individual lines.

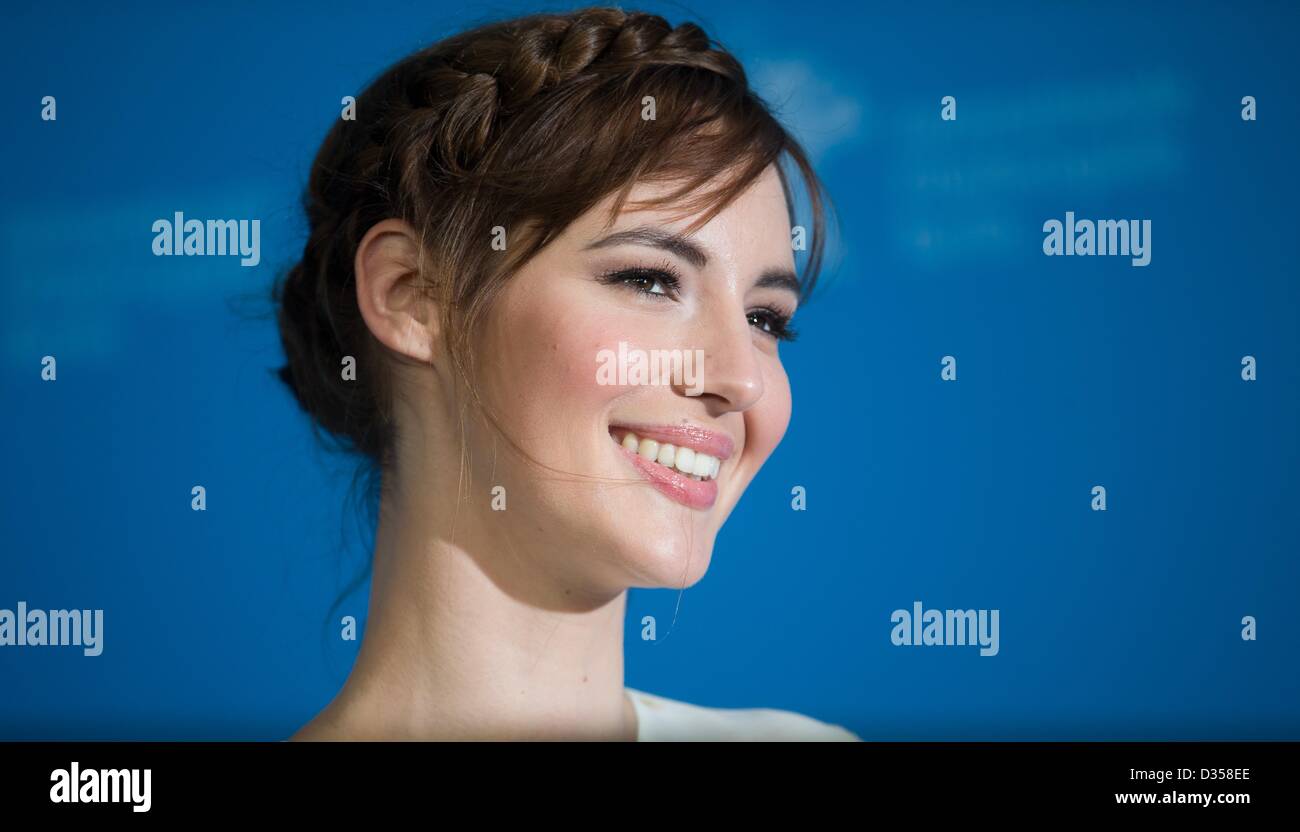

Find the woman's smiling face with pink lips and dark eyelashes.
xmin=468 ymin=162 xmax=798 ymax=593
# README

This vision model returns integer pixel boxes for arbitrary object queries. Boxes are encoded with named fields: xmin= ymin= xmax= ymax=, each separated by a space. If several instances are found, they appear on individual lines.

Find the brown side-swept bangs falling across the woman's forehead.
xmin=482 ymin=65 xmax=826 ymax=300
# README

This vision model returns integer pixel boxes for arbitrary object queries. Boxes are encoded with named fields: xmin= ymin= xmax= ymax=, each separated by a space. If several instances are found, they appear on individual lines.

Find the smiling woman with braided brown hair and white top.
xmin=277 ymin=8 xmax=857 ymax=741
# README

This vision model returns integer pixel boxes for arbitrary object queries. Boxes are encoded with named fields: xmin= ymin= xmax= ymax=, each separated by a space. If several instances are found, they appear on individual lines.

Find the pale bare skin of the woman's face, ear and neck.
xmin=293 ymin=162 xmax=798 ymax=740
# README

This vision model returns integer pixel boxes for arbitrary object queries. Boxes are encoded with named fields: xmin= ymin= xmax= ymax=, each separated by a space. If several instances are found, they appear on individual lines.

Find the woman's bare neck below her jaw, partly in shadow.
xmin=302 ymin=473 xmax=637 ymax=740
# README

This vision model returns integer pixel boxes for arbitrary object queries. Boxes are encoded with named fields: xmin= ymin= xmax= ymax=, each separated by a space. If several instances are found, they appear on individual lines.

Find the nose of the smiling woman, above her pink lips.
xmin=679 ymin=299 xmax=763 ymax=416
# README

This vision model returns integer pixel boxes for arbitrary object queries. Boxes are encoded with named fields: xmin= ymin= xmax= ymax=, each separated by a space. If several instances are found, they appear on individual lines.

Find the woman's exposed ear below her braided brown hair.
xmin=354 ymin=220 xmax=438 ymax=363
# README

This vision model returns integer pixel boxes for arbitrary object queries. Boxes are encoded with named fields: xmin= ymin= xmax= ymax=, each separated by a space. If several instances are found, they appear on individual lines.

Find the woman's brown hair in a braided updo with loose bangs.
xmin=274 ymin=8 xmax=823 ymax=464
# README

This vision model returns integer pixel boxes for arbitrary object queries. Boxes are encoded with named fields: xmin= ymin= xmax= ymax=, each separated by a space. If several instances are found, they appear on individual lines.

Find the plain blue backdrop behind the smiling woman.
xmin=0 ymin=0 xmax=1300 ymax=740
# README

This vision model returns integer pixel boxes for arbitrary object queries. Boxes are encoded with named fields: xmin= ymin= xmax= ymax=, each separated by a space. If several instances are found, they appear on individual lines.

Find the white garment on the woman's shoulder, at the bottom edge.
xmin=624 ymin=688 xmax=862 ymax=742
